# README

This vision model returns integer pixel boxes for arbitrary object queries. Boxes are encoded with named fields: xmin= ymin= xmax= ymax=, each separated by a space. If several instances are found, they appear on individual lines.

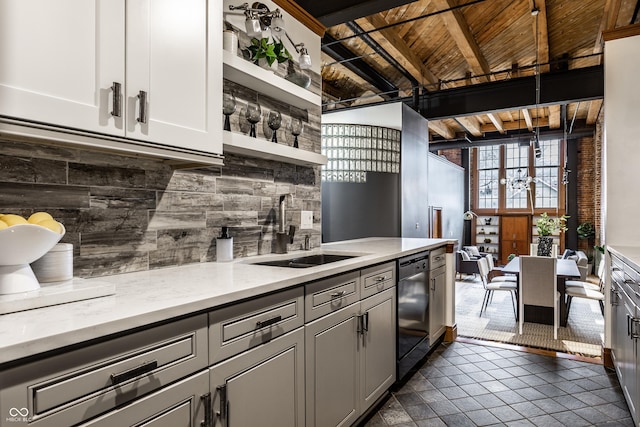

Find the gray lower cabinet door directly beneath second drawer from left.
xmin=210 ymin=328 xmax=305 ymax=427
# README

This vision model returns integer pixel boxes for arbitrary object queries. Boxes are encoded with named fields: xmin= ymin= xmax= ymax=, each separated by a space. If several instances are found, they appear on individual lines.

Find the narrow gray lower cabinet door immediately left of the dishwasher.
xmin=360 ymin=287 xmax=396 ymax=411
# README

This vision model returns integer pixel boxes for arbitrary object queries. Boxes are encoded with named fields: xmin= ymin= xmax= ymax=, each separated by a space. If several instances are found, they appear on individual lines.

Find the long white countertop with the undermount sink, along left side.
xmin=0 ymin=238 xmax=455 ymax=364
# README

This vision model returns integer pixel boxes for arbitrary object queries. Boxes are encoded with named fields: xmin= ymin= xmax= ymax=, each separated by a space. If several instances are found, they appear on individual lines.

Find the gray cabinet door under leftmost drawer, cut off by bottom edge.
xmin=77 ymin=371 xmax=209 ymax=427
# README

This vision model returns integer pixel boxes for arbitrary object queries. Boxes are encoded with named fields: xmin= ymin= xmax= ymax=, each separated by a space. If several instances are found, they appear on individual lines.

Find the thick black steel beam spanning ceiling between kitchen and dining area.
xmin=418 ymin=65 xmax=604 ymax=120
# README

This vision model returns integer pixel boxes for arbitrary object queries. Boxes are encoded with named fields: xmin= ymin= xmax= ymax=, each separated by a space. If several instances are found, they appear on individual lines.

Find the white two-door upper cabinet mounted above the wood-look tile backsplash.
xmin=0 ymin=0 xmax=222 ymax=159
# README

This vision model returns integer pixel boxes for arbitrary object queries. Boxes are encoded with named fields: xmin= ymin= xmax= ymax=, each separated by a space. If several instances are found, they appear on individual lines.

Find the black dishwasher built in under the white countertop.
xmin=396 ymin=251 xmax=429 ymax=382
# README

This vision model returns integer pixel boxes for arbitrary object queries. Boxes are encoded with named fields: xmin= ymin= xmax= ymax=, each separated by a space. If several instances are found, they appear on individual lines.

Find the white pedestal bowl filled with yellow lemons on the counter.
xmin=0 ymin=212 xmax=66 ymax=295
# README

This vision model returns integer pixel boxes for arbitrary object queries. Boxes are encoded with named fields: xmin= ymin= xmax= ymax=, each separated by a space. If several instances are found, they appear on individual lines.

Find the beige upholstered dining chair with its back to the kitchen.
xmin=518 ymin=255 xmax=560 ymax=339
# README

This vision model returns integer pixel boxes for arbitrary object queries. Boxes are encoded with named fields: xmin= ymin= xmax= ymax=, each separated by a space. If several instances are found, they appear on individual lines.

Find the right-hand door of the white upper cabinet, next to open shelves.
xmin=125 ymin=0 xmax=222 ymax=153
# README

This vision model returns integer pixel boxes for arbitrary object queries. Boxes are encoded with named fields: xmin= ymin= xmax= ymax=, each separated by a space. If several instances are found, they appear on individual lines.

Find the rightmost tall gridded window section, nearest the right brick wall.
xmin=534 ymin=139 xmax=560 ymax=208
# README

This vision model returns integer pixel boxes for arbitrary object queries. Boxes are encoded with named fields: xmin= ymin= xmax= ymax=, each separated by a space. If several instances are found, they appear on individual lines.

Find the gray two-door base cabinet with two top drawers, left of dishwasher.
xmin=305 ymin=263 xmax=396 ymax=427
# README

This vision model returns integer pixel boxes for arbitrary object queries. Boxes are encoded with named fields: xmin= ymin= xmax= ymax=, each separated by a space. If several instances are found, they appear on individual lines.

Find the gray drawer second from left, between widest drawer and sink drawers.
xmin=209 ymin=286 xmax=304 ymax=364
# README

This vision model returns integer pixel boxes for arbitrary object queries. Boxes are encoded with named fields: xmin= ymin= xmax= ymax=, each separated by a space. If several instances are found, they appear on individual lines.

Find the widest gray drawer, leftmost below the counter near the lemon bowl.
xmin=0 ymin=314 xmax=208 ymax=426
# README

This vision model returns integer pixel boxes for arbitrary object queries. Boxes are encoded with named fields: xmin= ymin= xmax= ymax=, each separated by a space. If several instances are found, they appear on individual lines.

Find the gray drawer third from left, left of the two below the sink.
xmin=304 ymin=271 xmax=360 ymax=322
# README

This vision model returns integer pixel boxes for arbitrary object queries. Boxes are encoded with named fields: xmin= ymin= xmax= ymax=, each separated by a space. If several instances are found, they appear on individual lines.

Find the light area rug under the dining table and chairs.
xmin=456 ymin=276 xmax=604 ymax=357
